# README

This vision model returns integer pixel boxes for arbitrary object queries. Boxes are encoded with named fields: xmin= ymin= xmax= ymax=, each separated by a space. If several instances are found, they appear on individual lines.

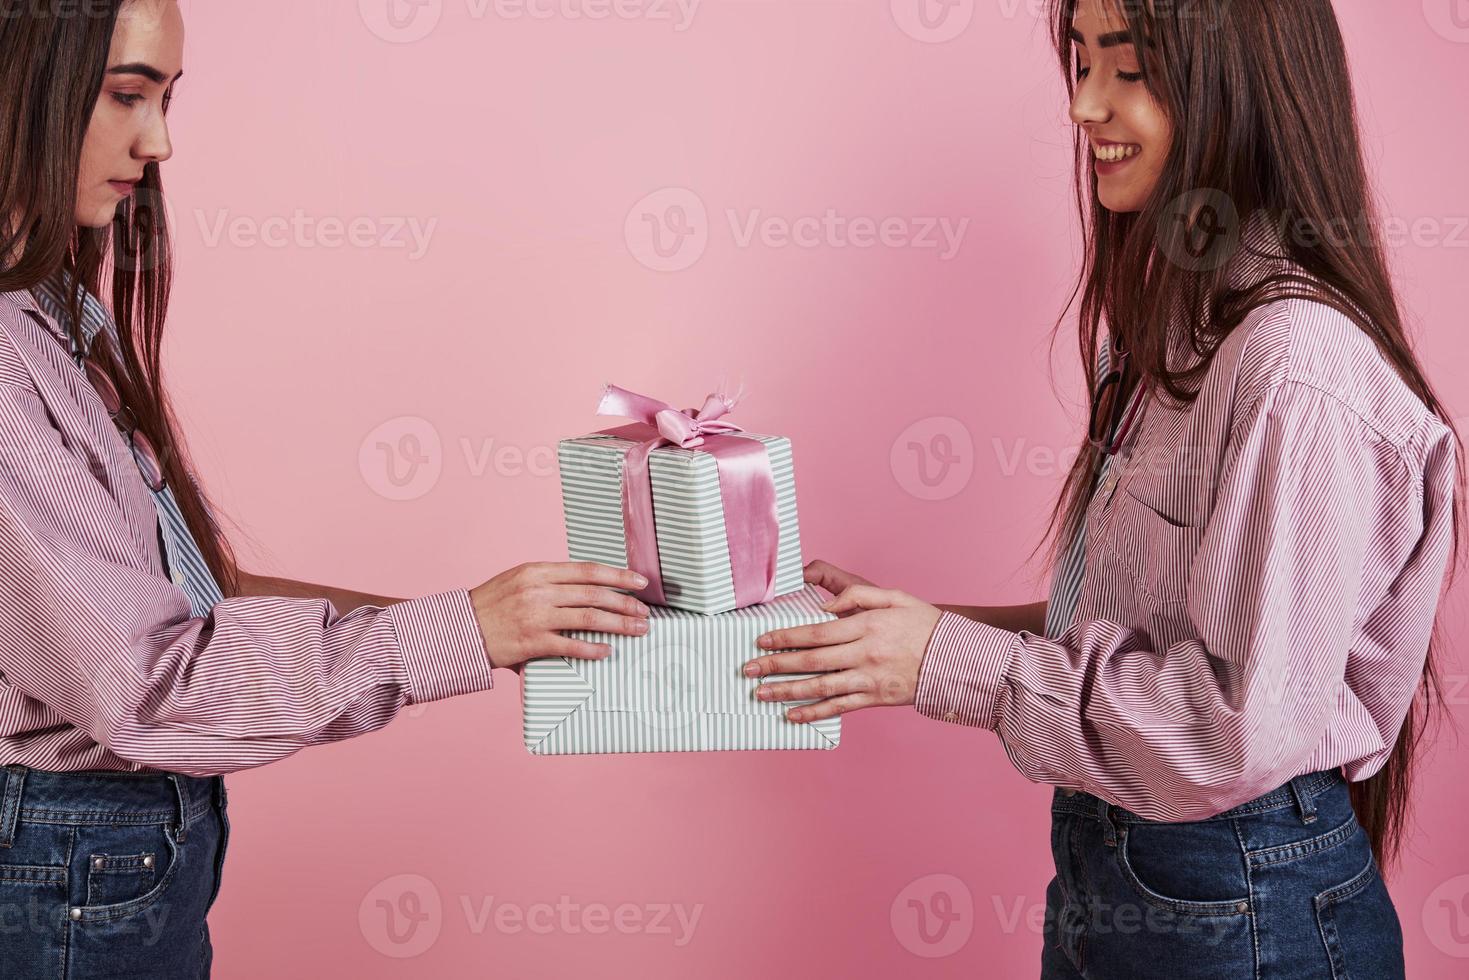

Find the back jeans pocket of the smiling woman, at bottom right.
xmin=1315 ymin=851 xmax=1404 ymax=980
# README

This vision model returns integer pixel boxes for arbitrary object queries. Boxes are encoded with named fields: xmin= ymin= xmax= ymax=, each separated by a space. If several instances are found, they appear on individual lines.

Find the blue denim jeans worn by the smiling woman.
xmin=1042 ymin=770 xmax=1403 ymax=980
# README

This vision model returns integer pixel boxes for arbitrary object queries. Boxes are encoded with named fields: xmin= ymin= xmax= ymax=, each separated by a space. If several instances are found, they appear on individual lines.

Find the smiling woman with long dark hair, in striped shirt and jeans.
xmin=749 ymin=0 xmax=1465 ymax=980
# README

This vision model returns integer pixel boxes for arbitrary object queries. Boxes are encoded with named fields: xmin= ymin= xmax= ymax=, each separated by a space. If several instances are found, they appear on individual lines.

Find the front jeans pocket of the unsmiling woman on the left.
xmin=71 ymin=823 xmax=182 ymax=923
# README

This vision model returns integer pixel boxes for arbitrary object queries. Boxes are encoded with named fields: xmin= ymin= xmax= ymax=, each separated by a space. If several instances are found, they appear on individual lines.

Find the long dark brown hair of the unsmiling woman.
xmin=0 ymin=0 xmax=239 ymax=597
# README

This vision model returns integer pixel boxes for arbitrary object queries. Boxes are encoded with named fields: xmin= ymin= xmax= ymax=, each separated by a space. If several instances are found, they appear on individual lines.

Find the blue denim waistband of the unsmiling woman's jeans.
xmin=0 ymin=765 xmax=223 ymax=848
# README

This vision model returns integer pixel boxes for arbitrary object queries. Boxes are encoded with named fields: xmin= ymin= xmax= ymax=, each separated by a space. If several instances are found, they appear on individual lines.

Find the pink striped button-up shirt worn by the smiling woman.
xmin=915 ymin=218 xmax=1456 ymax=820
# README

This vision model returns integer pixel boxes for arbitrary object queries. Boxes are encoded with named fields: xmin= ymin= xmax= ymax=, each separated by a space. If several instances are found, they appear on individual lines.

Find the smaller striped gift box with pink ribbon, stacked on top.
xmin=557 ymin=385 xmax=805 ymax=616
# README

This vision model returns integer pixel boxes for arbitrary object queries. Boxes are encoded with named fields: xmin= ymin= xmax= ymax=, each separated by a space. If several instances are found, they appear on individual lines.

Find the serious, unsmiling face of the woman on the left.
xmin=76 ymin=0 xmax=184 ymax=228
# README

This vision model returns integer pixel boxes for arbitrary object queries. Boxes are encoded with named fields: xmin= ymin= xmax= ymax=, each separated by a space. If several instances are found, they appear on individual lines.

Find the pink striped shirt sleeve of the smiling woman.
xmin=915 ymin=381 xmax=1453 ymax=820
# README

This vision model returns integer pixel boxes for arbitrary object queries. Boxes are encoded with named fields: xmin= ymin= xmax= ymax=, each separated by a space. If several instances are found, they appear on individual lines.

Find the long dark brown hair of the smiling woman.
xmin=1037 ymin=0 xmax=1465 ymax=868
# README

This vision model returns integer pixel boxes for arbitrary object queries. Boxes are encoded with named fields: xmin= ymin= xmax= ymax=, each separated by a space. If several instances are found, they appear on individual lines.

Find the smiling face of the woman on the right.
xmin=1071 ymin=0 xmax=1172 ymax=212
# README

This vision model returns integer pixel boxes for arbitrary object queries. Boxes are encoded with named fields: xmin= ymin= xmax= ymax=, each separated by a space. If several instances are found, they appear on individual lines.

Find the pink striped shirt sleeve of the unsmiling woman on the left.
xmin=0 ymin=383 xmax=492 ymax=776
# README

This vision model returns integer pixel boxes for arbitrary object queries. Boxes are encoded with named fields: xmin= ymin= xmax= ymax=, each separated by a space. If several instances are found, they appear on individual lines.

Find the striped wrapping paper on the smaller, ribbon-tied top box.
xmin=557 ymin=432 xmax=805 ymax=616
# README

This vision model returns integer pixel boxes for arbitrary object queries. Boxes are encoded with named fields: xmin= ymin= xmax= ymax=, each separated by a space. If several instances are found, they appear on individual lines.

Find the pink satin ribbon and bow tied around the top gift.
xmin=596 ymin=385 xmax=780 ymax=608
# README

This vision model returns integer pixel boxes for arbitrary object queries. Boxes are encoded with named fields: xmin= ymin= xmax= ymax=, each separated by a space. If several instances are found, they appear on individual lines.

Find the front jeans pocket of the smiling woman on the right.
xmin=1114 ymin=820 xmax=1250 ymax=915
